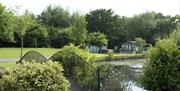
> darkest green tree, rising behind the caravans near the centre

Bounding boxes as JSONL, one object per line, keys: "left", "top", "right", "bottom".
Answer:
{"left": 86, "top": 9, "right": 125, "bottom": 48}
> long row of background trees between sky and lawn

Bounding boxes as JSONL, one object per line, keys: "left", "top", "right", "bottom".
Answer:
{"left": 0, "top": 4, "right": 180, "bottom": 49}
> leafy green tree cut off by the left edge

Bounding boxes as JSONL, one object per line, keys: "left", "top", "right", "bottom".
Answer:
{"left": 0, "top": 3, "right": 14, "bottom": 43}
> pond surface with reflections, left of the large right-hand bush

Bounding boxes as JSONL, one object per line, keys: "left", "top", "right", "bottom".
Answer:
{"left": 96, "top": 60, "right": 146, "bottom": 91}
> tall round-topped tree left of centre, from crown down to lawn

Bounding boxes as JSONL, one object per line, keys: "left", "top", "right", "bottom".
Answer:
{"left": 38, "top": 5, "right": 72, "bottom": 48}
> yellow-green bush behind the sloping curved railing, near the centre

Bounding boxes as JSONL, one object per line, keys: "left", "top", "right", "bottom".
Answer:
{"left": 52, "top": 45, "right": 95, "bottom": 88}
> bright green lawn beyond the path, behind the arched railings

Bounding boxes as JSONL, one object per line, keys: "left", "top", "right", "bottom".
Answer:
{"left": 0, "top": 48, "right": 60, "bottom": 59}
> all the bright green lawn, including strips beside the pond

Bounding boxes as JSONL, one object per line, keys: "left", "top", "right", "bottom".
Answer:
{"left": 0, "top": 48, "right": 143, "bottom": 67}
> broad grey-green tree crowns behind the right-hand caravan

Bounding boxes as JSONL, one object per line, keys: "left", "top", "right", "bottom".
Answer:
{"left": 125, "top": 12, "right": 177, "bottom": 45}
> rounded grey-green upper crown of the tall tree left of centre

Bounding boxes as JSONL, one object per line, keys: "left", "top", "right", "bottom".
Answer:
{"left": 39, "top": 5, "right": 71, "bottom": 28}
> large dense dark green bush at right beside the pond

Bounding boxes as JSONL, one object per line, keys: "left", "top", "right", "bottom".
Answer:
{"left": 139, "top": 39, "right": 180, "bottom": 91}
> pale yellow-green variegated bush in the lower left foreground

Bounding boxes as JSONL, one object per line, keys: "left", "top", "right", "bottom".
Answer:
{"left": 0, "top": 61, "right": 70, "bottom": 91}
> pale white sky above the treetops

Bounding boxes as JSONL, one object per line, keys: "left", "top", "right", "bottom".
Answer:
{"left": 0, "top": 0, "right": 180, "bottom": 16}
